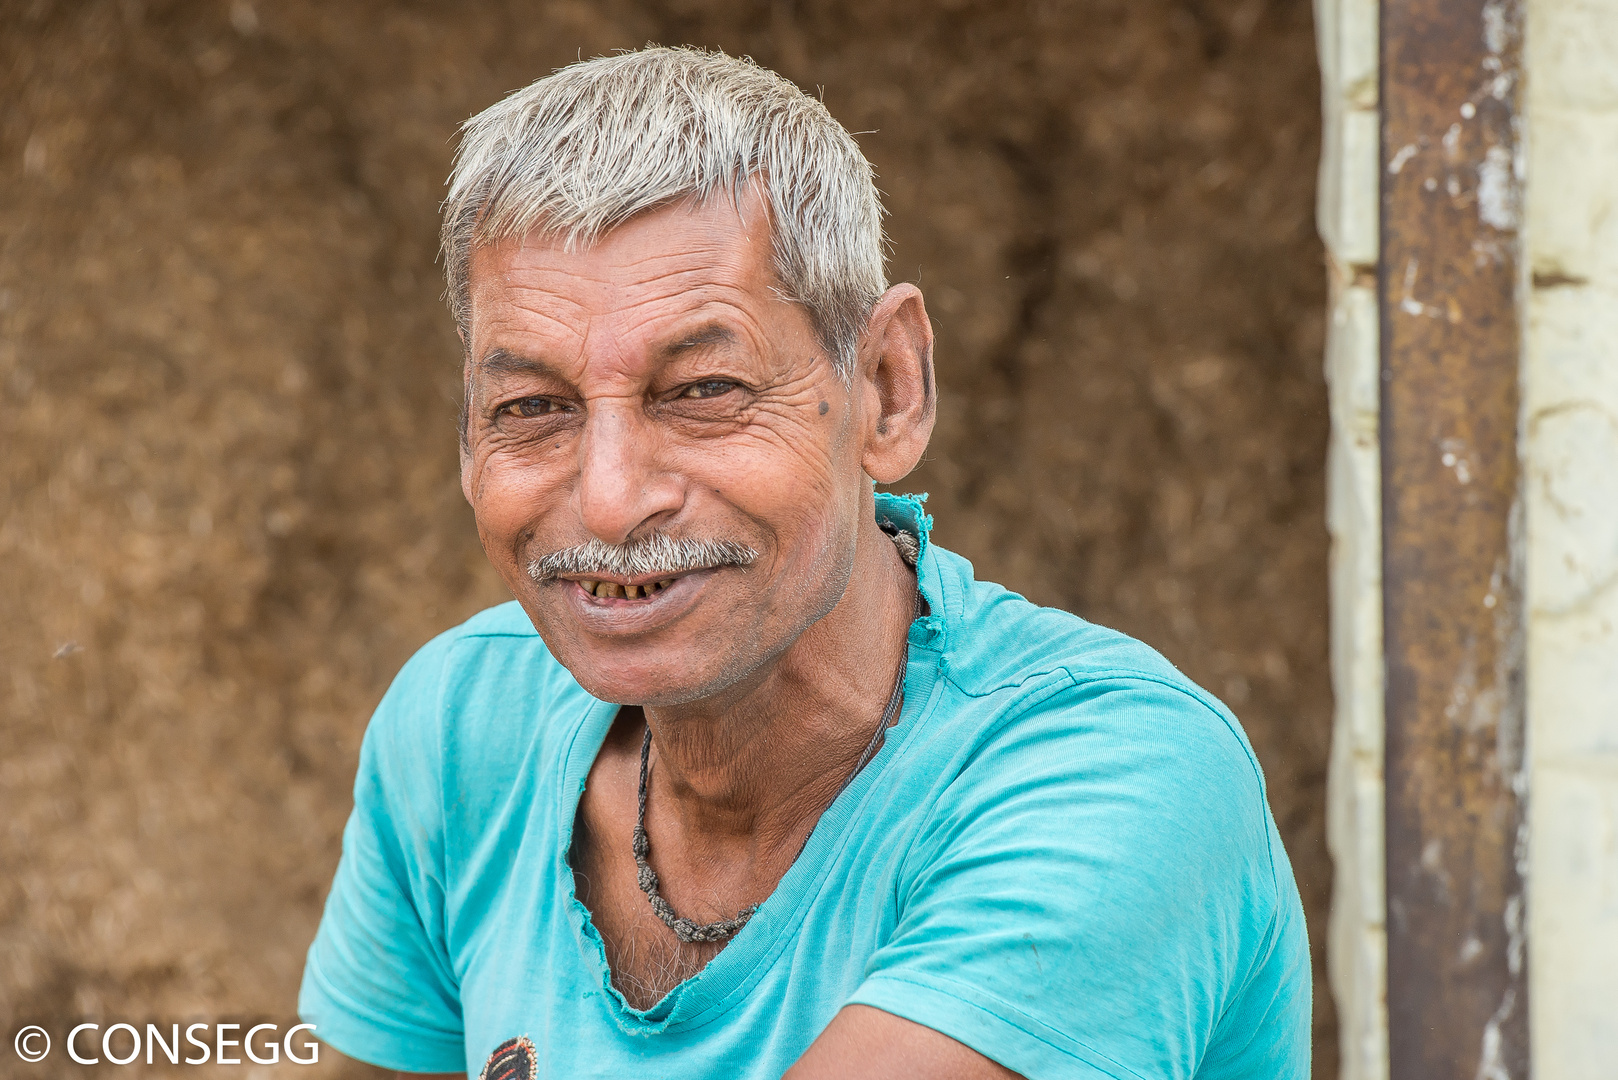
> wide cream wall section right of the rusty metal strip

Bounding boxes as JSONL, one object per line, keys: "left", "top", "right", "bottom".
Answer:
{"left": 1523, "top": 0, "right": 1618, "bottom": 1080}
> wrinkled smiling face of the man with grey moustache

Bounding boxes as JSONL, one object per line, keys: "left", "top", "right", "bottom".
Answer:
{"left": 461, "top": 193, "right": 869, "bottom": 704}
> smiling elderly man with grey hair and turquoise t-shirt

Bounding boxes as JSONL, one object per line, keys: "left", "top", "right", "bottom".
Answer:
{"left": 301, "top": 49, "right": 1309, "bottom": 1080}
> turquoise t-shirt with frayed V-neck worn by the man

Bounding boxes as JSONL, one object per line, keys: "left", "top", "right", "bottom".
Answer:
{"left": 299, "top": 495, "right": 1311, "bottom": 1080}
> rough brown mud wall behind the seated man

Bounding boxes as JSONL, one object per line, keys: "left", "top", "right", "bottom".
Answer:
{"left": 0, "top": 0, "right": 1335, "bottom": 1078}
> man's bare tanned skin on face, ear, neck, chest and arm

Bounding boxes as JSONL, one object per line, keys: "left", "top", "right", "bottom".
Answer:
{"left": 393, "top": 188, "right": 1013, "bottom": 1080}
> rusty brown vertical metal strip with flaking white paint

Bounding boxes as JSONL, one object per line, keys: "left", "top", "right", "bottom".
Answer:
{"left": 1379, "top": 0, "right": 1529, "bottom": 1080}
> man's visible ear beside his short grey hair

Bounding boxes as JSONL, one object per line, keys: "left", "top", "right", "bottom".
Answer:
{"left": 854, "top": 283, "right": 937, "bottom": 484}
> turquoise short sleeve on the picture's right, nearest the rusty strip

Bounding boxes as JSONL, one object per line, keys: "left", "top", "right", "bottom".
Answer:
{"left": 851, "top": 678, "right": 1307, "bottom": 1080}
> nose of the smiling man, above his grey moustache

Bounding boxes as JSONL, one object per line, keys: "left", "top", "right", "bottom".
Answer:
{"left": 576, "top": 397, "right": 684, "bottom": 544}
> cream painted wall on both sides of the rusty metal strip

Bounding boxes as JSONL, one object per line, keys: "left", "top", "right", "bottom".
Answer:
{"left": 1315, "top": 0, "right": 1618, "bottom": 1080}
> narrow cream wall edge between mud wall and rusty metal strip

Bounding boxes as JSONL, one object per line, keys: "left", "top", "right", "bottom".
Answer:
{"left": 1315, "top": 0, "right": 1388, "bottom": 1080}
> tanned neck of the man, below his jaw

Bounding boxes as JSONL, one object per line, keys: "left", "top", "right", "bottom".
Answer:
{"left": 646, "top": 518, "right": 916, "bottom": 861}
